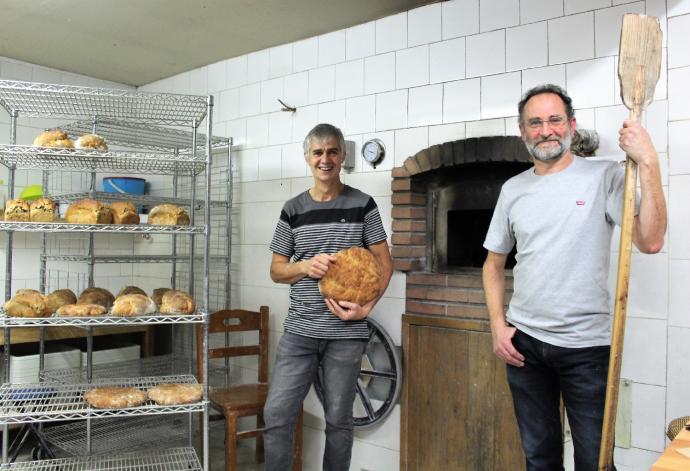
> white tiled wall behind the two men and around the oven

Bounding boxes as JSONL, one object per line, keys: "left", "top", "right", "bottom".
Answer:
{"left": 134, "top": 0, "right": 690, "bottom": 470}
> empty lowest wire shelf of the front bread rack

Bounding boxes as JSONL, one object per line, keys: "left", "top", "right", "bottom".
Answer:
{"left": 0, "top": 447, "right": 201, "bottom": 471}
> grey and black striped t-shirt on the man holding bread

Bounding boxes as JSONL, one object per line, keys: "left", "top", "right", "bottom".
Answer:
{"left": 270, "top": 185, "right": 386, "bottom": 339}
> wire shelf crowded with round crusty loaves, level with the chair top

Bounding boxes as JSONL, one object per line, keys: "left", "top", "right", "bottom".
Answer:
{"left": 0, "top": 286, "right": 205, "bottom": 327}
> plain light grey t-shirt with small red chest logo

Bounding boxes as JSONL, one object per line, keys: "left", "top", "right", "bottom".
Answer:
{"left": 484, "top": 157, "right": 625, "bottom": 348}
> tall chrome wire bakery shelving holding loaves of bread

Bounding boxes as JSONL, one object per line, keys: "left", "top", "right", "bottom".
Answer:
{"left": 0, "top": 80, "right": 220, "bottom": 471}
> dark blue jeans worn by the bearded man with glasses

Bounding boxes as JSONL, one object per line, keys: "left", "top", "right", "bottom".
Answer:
{"left": 507, "top": 330, "right": 610, "bottom": 471}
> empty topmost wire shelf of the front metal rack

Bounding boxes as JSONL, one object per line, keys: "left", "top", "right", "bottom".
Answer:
{"left": 0, "top": 80, "right": 208, "bottom": 126}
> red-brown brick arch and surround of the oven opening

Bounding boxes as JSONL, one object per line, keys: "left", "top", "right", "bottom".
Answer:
{"left": 391, "top": 136, "right": 530, "bottom": 320}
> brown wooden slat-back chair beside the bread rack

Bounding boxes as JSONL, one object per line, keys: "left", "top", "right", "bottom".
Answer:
{"left": 196, "top": 306, "right": 302, "bottom": 471}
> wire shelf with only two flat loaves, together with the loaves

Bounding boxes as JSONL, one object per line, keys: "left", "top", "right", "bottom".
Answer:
{"left": 0, "top": 375, "right": 203, "bottom": 424}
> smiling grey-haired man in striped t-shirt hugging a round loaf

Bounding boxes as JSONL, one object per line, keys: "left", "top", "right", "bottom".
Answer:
{"left": 264, "top": 124, "right": 393, "bottom": 471}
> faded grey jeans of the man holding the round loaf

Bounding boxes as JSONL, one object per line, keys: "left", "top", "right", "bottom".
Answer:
{"left": 264, "top": 332, "right": 367, "bottom": 471}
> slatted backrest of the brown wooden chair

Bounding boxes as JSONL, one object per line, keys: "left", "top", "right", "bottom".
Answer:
{"left": 196, "top": 306, "right": 268, "bottom": 383}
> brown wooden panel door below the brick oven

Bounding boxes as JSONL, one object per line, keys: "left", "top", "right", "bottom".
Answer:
{"left": 402, "top": 325, "right": 525, "bottom": 471}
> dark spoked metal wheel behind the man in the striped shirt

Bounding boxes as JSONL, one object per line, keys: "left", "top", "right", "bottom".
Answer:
{"left": 314, "top": 318, "right": 402, "bottom": 428}
